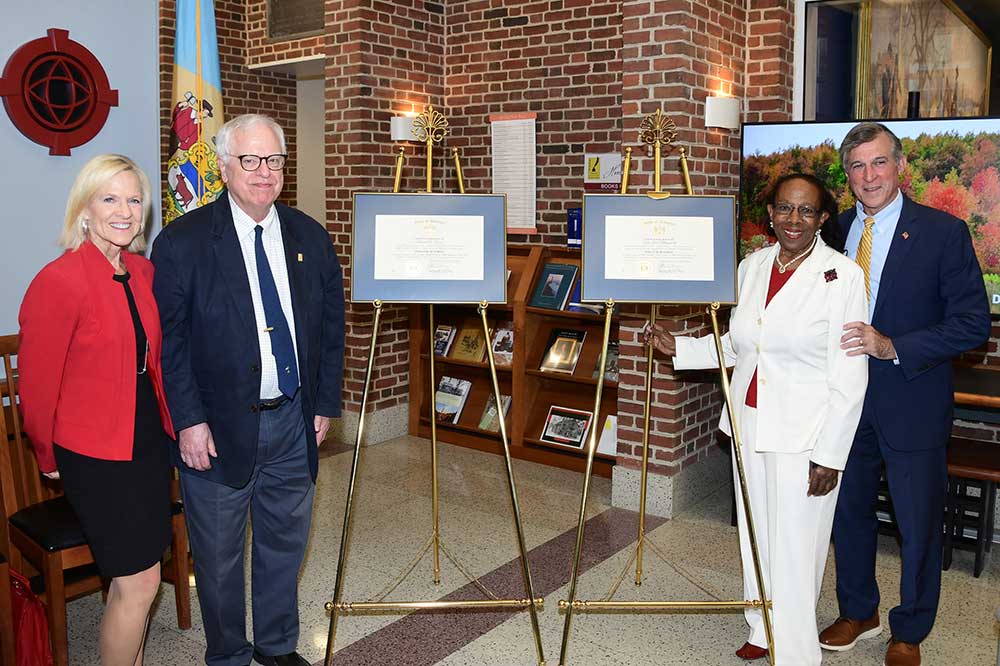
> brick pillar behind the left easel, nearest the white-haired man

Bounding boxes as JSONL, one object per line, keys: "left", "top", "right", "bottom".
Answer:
{"left": 325, "top": 0, "right": 448, "bottom": 442}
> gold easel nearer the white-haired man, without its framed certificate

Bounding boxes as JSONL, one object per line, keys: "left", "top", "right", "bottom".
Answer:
{"left": 324, "top": 106, "right": 545, "bottom": 666}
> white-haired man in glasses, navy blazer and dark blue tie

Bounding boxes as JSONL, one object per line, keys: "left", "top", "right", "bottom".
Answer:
{"left": 152, "top": 115, "right": 344, "bottom": 666}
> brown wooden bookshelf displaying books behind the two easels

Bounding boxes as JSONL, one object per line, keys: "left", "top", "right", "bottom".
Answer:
{"left": 409, "top": 245, "right": 618, "bottom": 476}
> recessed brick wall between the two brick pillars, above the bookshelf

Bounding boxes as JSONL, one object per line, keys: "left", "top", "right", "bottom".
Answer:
{"left": 445, "top": 0, "right": 622, "bottom": 245}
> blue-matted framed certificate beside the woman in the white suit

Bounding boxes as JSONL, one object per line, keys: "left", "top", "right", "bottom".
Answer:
{"left": 582, "top": 194, "right": 737, "bottom": 305}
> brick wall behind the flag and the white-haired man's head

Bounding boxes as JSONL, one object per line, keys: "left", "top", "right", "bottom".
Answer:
{"left": 159, "top": 0, "right": 296, "bottom": 205}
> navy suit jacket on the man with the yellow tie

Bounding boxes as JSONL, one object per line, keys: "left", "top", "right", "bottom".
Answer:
{"left": 839, "top": 196, "right": 990, "bottom": 451}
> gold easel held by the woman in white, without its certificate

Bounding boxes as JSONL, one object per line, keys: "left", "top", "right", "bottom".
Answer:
{"left": 559, "top": 109, "right": 774, "bottom": 666}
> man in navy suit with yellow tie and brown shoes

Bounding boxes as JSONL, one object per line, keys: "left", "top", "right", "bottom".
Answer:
{"left": 820, "top": 122, "right": 990, "bottom": 666}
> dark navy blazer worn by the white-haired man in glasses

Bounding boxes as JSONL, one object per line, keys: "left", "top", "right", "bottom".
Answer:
{"left": 151, "top": 194, "right": 344, "bottom": 487}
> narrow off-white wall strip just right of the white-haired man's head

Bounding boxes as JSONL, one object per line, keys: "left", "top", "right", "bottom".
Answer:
{"left": 295, "top": 77, "right": 326, "bottom": 224}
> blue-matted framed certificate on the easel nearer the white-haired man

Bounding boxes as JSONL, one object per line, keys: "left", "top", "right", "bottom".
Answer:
{"left": 351, "top": 192, "right": 507, "bottom": 303}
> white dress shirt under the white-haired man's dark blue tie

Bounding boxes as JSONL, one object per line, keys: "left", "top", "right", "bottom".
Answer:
{"left": 229, "top": 192, "right": 301, "bottom": 400}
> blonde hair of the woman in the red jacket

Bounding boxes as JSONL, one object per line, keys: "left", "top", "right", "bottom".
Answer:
{"left": 59, "top": 153, "right": 153, "bottom": 252}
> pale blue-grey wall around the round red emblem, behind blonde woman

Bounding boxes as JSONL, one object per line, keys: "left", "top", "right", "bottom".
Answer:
{"left": 0, "top": 0, "right": 161, "bottom": 335}
